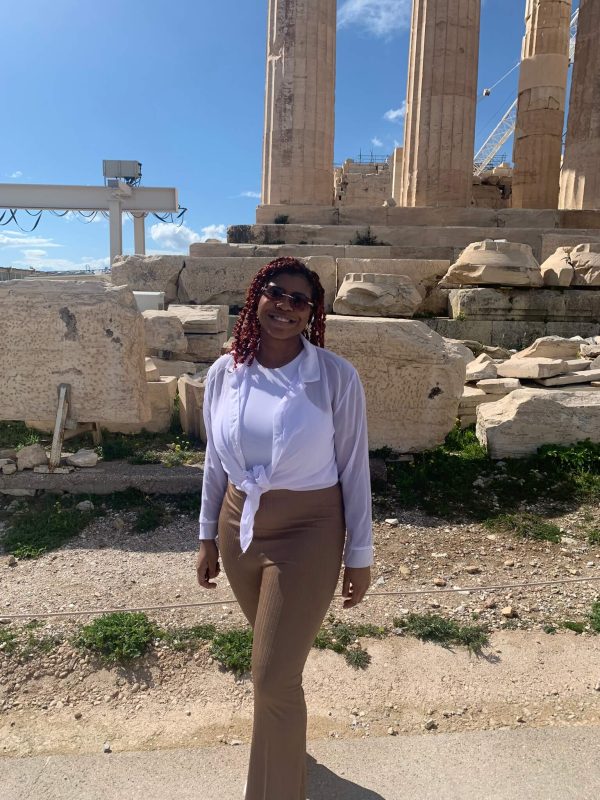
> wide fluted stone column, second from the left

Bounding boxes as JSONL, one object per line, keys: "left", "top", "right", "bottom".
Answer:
{"left": 400, "top": 0, "right": 481, "bottom": 206}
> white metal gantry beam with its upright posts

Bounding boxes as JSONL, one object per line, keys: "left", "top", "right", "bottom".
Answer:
{"left": 0, "top": 181, "right": 179, "bottom": 264}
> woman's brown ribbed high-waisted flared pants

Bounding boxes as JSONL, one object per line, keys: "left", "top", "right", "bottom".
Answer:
{"left": 219, "top": 484, "right": 345, "bottom": 800}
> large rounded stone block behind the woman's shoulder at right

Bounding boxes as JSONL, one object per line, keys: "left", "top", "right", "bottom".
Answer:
{"left": 326, "top": 316, "right": 465, "bottom": 453}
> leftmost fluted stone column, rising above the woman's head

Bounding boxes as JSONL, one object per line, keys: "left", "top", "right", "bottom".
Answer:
{"left": 262, "top": 0, "right": 337, "bottom": 205}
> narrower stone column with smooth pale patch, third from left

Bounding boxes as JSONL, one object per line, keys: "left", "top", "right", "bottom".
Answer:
{"left": 512, "top": 0, "right": 571, "bottom": 208}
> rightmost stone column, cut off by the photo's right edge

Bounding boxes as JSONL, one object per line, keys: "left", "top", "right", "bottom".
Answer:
{"left": 559, "top": 0, "right": 600, "bottom": 209}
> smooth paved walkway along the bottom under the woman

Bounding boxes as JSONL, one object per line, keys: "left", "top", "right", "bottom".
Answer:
{"left": 0, "top": 727, "right": 600, "bottom": 800}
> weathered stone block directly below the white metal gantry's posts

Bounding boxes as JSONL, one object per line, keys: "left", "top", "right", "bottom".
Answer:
{"left": 111, "top": 255, "right": 185, "bottom": 303}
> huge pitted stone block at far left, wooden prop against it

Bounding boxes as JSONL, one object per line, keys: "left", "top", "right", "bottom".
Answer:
{"left": 0, "top": 280, "right": 150, "bottom": 424}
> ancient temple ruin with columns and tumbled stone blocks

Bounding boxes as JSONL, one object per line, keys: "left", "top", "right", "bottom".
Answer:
{"left": 0, "top": 0, "right": 600, "bottom": 480}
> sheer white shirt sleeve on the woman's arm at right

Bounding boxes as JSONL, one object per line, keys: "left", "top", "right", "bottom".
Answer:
{"left": 333, "top": 372, "right": 373, "bottom": 567}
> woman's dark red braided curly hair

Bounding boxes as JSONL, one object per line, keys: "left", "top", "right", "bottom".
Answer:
{"left": 230, "top": 256, "right": 325, "bottom": 367}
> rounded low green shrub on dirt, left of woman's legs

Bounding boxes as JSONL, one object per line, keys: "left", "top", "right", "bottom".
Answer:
{"left": 74, "top": 611, "right": 159, "bottom": 662}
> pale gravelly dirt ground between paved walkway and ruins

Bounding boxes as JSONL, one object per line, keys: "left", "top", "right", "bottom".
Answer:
{"left": 0, "top": 500, "right": 600, "bottom": 756}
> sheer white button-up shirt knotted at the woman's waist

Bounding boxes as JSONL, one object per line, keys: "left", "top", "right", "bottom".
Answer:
{"left": 199, "top": 337, "right": 373, "bottom": 567}
